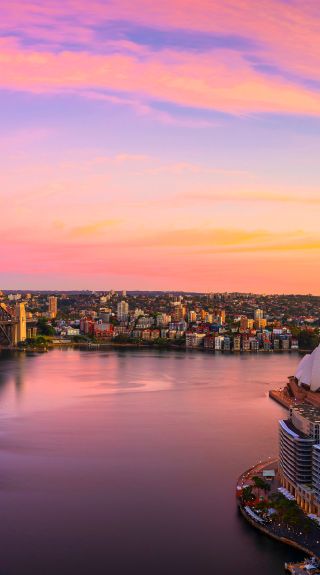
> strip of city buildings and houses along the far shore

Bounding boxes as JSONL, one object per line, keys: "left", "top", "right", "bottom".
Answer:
{"left": 0, "top": 290, "right": 320, "bottom": 352}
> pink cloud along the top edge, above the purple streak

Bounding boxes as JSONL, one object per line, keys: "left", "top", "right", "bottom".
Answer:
{"left": 1, "top": 0, "right": 320, "bottom": 83}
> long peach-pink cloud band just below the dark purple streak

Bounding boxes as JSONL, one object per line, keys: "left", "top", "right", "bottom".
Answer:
{"left": 0, "top": 40, "right": 320, "bottom": 115}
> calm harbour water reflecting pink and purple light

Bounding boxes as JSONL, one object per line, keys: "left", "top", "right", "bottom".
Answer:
{"left": 0, "top": 350, "right": 300, "bottom": 575}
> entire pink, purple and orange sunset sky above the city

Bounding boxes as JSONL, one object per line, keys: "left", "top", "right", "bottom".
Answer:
{"left": 0, "top": 0, "right": 320, "bottom": 295}
